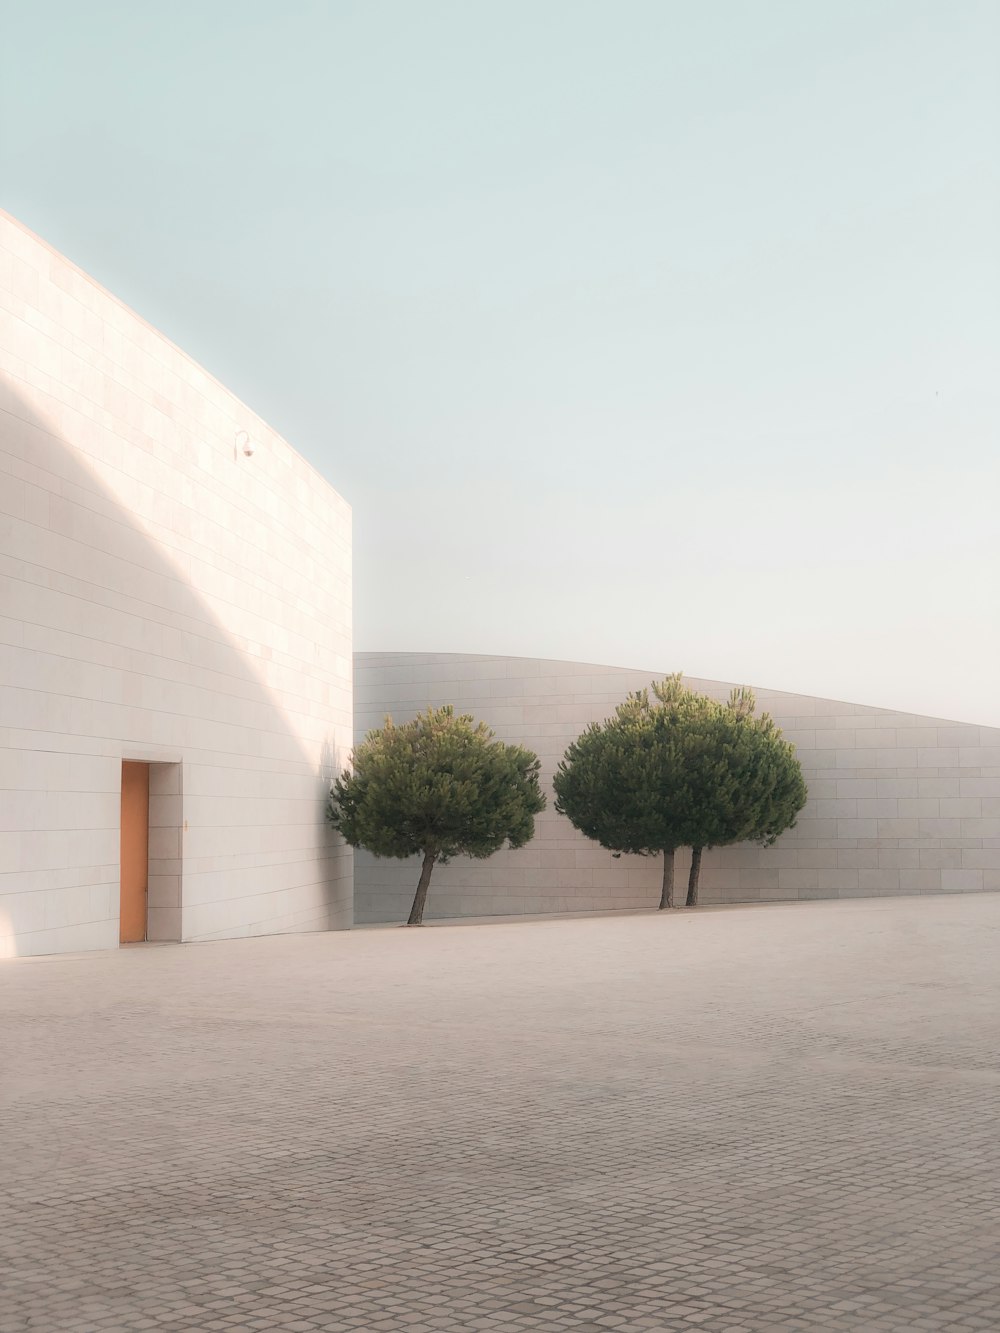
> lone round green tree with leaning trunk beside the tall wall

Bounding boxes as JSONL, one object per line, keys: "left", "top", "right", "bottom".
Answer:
{"left": 328, "top": 706, "right": 545, "bottom": 925}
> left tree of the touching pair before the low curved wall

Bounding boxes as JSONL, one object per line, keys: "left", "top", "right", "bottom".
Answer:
{"left": 553, "top": 674, "right": 719, "bottom": 909}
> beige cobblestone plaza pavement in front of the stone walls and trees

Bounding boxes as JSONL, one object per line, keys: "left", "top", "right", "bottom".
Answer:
{"left": 0, "top": 894, "right": 1000, "bottom": 1333}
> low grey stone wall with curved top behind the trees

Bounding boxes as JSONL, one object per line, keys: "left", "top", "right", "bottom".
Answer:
{"left": 355, "top": 653, "right": 1000, "bottom": 922}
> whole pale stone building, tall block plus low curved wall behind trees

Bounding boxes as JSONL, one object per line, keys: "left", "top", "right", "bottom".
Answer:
{"left": 0, "top": 213, "right": 1000, "bottom": 957}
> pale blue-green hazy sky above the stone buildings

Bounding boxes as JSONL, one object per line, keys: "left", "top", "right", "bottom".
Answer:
{"left": 0, "top": 0, "right": 1000, "bottom": 725}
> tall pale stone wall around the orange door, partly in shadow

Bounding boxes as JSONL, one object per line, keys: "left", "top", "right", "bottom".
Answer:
{"left": 0, "top": 215, "right": 352, "bottom": 953}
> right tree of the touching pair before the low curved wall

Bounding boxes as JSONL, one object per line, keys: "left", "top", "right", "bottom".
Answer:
{"left": 687, "top": 688, "right": 807, "bottom": 908}
